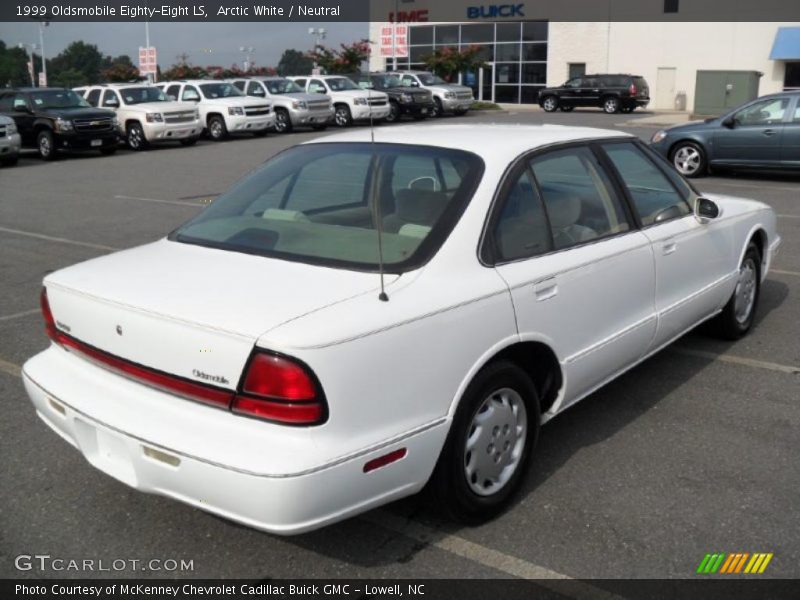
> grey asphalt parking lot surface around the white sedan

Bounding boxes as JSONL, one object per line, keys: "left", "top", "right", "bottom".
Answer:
{"left": 0, "top": 110, "right": 800, "bottom": 579}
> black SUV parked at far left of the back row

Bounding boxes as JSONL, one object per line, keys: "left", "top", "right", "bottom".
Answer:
{"left": 0, "top": 88, "right": 119, "bottom": 160}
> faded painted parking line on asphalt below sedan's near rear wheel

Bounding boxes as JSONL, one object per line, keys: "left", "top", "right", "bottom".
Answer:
{"left": 360, "top": 510, "right": 619, "bottom": 600}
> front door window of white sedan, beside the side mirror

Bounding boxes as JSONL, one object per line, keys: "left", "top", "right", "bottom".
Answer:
{"left": 603, "top": 143, "right": 692, "bottom": 226}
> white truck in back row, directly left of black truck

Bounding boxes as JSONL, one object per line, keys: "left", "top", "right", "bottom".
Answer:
{"left": 289, "top": 75, "right": 391, "bottom": 127}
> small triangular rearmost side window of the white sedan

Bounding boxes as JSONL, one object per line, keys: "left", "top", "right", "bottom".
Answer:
{"left": 494, "top": 169, "right": 552, "bottom": 260}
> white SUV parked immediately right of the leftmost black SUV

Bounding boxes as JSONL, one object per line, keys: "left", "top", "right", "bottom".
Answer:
{"left": 74, "top": 83, "right": 203, "bottom": 150}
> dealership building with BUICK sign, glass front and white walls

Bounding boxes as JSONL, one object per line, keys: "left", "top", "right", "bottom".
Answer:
{"left": 369, "top": 0, "right": 800, "bottom": 111}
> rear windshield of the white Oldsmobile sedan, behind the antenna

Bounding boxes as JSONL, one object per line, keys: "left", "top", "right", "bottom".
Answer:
{"left": 170, "top": 143, "right": 483, "bottom": 273}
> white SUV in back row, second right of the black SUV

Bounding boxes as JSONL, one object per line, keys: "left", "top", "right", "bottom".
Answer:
{"left": 158, "top": 79, "right": 275, "bottom": 141}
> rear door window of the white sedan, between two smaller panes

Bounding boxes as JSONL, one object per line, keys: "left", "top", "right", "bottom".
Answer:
{"left": 531, "top": 147, "right": 630, "bottom": 250}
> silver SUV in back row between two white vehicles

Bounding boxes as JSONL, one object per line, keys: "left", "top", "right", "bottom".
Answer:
{"left": 228, "top": 77, "right": 333, "bottom": 133}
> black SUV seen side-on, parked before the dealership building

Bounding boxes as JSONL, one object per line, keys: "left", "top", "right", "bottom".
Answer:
{"left": 539, "top": 75, "right": 650, "bottom": 114}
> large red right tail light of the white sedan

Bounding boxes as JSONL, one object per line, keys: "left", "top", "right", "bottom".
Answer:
{"left": 231, "top": 352, "right": 327, "bottom": 425}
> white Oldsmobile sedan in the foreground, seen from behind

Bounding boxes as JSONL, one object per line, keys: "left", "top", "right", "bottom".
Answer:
{"left": 23, "top": 125, "right": 780, "bottom": 534}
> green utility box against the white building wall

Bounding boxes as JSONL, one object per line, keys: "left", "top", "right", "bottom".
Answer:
{"left": 694, "top": 71, "right": 763, "bottom": 117}
